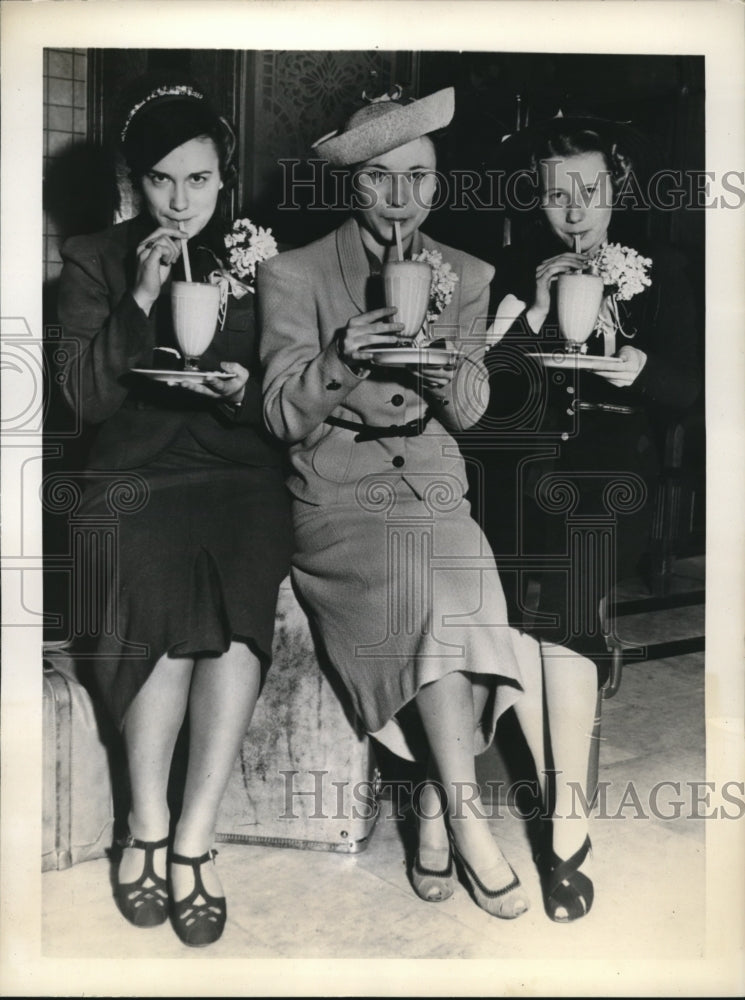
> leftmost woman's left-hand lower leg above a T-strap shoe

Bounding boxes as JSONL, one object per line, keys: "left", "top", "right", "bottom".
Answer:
{"left": 119, "top": 655, "right": 194, "bottom": 882}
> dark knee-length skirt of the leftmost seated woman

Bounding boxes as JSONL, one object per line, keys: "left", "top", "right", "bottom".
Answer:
{"left": 76, "top": 432, "right": 292, "bottom": 726}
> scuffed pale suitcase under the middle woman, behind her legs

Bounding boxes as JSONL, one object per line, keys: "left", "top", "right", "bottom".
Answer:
{"left": 216, "top": 578, "right": 380, "bottom": 854}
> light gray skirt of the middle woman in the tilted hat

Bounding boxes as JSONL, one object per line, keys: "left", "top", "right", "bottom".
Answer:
{"left": 292, "top": 480, "right": 522, "bottom": 760}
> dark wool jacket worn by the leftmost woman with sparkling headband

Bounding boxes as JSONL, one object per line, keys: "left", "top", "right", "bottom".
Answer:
{"left": 59, "top": 215, "right": 282, "bottom": 469}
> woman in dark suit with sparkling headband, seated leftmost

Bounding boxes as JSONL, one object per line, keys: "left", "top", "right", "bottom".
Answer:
{"left": 59, "top": 82, "right": 291, "bottom": 945}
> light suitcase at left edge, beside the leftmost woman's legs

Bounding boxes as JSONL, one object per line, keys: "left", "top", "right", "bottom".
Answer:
{"left": 41, "top": 651, "right": 114, "bottom": 871}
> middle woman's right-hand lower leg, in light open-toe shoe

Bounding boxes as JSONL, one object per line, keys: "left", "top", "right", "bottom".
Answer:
{"left": 416, "top": 673, "right": 527, "bottom": 912}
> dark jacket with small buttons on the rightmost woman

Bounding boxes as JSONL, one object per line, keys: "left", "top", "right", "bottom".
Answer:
{"left": 476, "top": 240, "right": 702, "bottom": 456}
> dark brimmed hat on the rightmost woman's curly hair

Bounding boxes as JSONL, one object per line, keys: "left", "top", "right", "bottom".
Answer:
{"left": 500, "top": 114, "right": 651, "bottom": 169}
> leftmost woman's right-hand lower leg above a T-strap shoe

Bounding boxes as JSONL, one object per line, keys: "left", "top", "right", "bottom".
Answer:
{"left": 171, "top": 642, "right": 261, "bottom": 900}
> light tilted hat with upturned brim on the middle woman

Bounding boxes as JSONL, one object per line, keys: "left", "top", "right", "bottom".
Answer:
{"left": 312, "top": 87, "right": 455, "bottom": 167}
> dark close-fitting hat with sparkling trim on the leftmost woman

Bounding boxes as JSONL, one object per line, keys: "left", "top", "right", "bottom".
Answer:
{"left": 120, "top": 84, "right": 221, "bottom": 175}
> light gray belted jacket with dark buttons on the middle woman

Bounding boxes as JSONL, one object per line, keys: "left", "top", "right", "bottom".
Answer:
{"left": 258, "top": 218, "right": 494, "bottom": 504}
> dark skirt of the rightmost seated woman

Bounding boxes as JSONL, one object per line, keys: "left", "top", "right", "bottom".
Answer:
{"left": 471, "top": 413, "right": 658, "bottom": 685}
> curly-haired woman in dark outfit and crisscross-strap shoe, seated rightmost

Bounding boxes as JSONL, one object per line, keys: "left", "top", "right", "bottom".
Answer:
{"left": 476, "top": 118, "right": 700, "bottom": 922}
